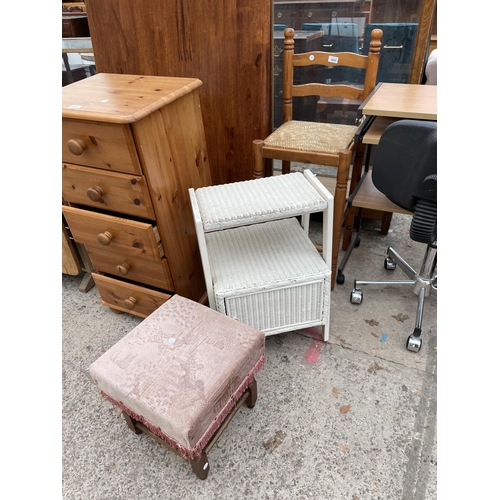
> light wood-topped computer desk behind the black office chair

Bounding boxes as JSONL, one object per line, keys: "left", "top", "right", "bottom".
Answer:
{"left": 342, "top": 83, "right": 437, "bottom": 250}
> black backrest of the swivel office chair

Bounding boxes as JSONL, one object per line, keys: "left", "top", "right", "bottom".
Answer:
{"left": 372, "top": 120, "right": 437, "bottom": 212}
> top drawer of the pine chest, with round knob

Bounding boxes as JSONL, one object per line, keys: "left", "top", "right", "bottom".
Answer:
{"left": 62, "top": 118, "right": 142, "bottom": 175}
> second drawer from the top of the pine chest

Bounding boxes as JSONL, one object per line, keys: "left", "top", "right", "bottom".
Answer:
{"left": 62, "top": 163, "right": 155, "bottom": 219}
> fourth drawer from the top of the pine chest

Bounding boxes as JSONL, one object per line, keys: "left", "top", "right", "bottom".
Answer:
{"left": 85, "top": 246, "right": 174, "bottom": 290}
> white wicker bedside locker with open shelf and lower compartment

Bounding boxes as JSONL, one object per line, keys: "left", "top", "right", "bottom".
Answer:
{"left": 189, "top": 170, "right": 333, "bottom": 342}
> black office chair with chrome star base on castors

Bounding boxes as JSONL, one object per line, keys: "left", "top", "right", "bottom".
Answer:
{"left": 351, "top": 120, "right": 437, "bottom": 352}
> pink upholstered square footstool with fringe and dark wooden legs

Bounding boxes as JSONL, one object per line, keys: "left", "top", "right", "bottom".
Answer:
{"left": 90, "top": 295, "right": 265, "bottom": 479}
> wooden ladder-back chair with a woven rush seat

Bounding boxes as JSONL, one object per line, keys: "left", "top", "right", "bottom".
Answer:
{"left": 253, "top": 28, "right": 383, "bottom": 288}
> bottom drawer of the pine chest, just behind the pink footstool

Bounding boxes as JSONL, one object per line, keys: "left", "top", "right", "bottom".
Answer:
{"left": 92, "top": 273, "right": 172, "bottom": 318}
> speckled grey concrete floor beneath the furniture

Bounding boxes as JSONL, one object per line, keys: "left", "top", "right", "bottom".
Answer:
{"left": 62, "top": 208, "right": 437, "bottom": 500}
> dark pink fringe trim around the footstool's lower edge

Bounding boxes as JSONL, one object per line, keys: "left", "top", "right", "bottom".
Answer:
{"left": 101, "top": 354, "right": 266, "bottom": 460}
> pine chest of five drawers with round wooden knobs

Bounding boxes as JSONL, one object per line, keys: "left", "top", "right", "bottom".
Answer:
{"left": 62, "top": 73, "right": 211, "bottom": 317}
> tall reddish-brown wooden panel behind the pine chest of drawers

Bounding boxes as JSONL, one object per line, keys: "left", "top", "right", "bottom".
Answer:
{"left": 86, "top": 0, "right": 272, "bottom": 184}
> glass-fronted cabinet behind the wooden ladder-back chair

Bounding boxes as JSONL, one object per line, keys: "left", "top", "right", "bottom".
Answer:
{"left": 273, "top": 0, "right": 437, "bottom": 128}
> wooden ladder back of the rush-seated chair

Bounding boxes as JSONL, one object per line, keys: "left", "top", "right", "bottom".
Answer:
{"left": 283, "top": 28, "right": 383, "bottom": 122}
